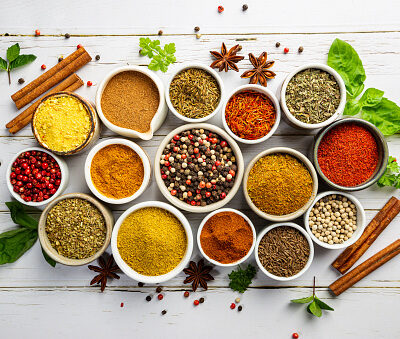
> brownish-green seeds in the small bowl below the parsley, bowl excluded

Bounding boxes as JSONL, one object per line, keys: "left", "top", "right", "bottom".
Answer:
{"left": 169, "top": 68, "right": 221, "bottom": 119}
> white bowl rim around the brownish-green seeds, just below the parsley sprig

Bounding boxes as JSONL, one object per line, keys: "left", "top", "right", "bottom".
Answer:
{"left": 165, "top": 63, "right": 224, "bottom": 122}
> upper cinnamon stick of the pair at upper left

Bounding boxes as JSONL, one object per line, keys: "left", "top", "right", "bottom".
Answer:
{"left": 11, "top": 47, "right": 92, "bottom": 109}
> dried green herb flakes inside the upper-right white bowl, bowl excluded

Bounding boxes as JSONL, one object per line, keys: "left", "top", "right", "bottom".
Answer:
{"left": 285, "top": 68, "right": 340, "bottom": 124}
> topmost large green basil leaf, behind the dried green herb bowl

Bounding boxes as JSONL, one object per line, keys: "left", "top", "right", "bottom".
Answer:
{"left": 328, "top": 39, "right": 366, "bottom": 98}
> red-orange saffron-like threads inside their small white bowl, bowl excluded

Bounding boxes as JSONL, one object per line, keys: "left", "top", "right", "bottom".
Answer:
{"left": 225, "top": 91, "right": 276, "bottom": 140}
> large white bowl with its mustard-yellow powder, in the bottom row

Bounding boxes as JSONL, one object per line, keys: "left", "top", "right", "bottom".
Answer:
{"left": 111, "top": 201, "right": 193, "bottom": 284}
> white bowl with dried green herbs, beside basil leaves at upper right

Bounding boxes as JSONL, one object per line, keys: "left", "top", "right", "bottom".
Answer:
{"left": 281, "top": 64, "right": 346, "bottom": 129}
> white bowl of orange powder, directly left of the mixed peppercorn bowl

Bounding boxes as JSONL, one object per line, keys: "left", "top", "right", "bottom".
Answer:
{"left": 85, "top": 138, "right": 151, "bottom": 204}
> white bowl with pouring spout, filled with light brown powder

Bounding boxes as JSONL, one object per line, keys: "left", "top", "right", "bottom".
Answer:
{"left": 96, "top": 66, "right": 168, "bottom": 140}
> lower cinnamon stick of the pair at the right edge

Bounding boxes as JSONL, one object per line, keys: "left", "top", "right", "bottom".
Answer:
{"left": 329, "top": 239, "right": 400, "bottom": 296}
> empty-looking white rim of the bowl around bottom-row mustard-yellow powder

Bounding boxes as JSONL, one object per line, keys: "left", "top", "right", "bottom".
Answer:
{"left": 111, "top": 201, "right": 193, "bottom": 284}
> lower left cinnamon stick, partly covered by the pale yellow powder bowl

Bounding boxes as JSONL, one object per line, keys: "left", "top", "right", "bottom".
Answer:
{"left": 6, "top": 73, "right": 83, "bottom": 134}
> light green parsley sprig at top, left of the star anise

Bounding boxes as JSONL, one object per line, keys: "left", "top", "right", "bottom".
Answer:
{"left": 139, "top": 38, "right": 176, "bottom": 73}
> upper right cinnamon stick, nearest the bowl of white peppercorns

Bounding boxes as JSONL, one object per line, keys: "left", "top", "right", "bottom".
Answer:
{"left": 332, "top": 197, "right": 400, "bottom": 274}
